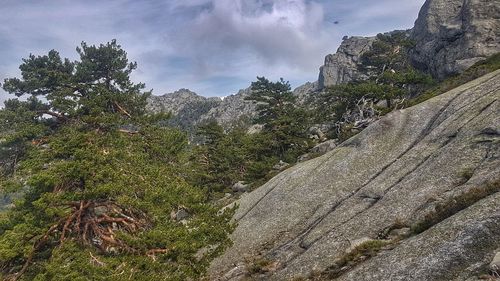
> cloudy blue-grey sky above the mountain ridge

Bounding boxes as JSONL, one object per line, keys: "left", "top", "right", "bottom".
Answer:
{"left": 0, "top": 0, "right": 424, "bottom": 103}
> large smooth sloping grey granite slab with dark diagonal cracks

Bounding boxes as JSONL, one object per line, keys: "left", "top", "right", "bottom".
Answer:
{"left": 210, "top": 70, "right": 500, "bottom": 281}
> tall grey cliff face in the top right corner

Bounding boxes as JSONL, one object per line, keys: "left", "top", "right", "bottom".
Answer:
{"left": 411, "top": 0, "right": 500, "bottom": 79}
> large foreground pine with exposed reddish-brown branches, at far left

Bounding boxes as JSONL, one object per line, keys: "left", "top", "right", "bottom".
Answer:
{"left": 0, "top": 41, "right": 232, "bottom": 280}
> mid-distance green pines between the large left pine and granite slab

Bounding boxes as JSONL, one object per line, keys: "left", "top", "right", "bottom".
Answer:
{"left": 192, "top": 77, "right": 312, "bottom": 197}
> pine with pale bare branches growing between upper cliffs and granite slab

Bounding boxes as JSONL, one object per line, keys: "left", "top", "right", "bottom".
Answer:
{"left": 312, "top": 31, "right": 434, "bottom": 140}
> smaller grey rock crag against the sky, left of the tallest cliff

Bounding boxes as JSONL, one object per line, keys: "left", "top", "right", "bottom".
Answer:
{"left": 318, "top": 36, "right": 375, "bottom": 89}
